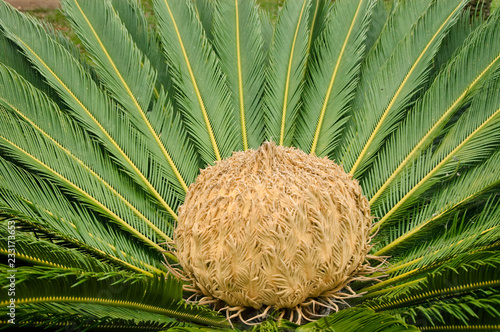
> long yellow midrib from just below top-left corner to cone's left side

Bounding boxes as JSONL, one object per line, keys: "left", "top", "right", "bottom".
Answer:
{"left": 12, "top": 37, "right": 178, "bottom": 221}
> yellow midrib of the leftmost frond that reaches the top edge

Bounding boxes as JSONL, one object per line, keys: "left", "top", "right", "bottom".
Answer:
{"left": 74, "top": 0, "right": 188, "bottom": 193}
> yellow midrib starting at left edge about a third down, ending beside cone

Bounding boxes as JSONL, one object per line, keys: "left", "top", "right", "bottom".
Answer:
{"left": 0, "top": 98, "right": 172, "bottom": 241}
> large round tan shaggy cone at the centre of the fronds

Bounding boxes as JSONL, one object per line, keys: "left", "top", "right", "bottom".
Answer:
{"left": 175, "top": 143, "right": 371, "bottom": 309}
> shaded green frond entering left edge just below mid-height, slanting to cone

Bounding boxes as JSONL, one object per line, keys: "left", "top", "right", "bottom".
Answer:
{"left": 0, "top": 158, "right": 163, "bottom": 274}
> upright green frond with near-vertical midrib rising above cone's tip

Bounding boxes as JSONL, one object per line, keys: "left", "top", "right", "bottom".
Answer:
{"left": 214, "top": 0, "right": 265, "bottom": 150}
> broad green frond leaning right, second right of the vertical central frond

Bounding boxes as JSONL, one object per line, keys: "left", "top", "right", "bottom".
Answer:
{"left": 295, "top": 0, "right": 374, "bottom": 157}
